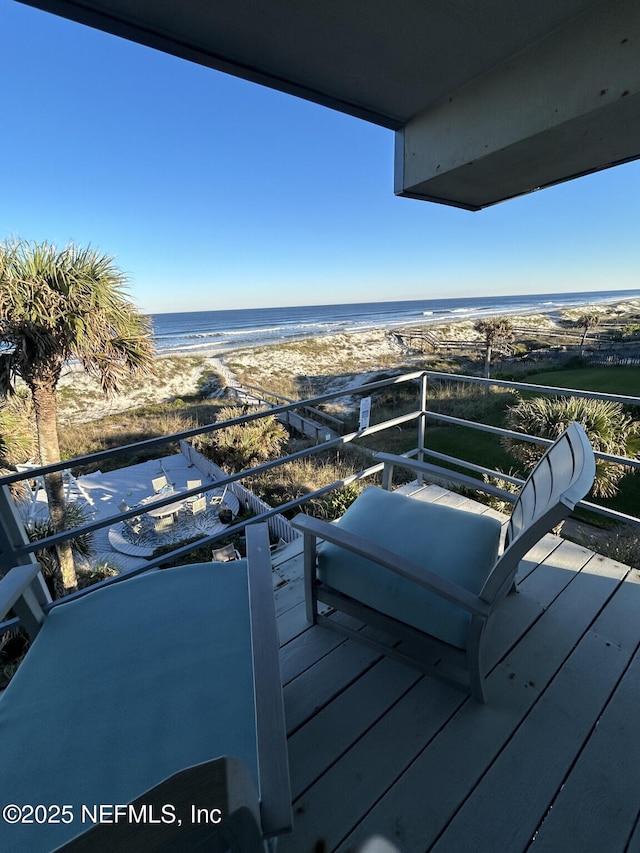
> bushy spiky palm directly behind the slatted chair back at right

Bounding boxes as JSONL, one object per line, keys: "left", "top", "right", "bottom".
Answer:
{"left": 504, "top": 397, "right": 640, "bottom": 498}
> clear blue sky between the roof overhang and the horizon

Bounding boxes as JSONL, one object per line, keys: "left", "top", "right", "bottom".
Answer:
{"left": 0, "top": 0, "right": 640, "bottom": 312}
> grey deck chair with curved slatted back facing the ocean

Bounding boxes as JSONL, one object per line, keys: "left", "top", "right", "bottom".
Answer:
{"left": 292, "top": 423, "right": 595, "bottom": 702}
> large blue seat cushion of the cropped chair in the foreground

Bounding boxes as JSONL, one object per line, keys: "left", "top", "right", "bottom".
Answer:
{"left": 0, "top": 560, "right": 258, "bottom": 853}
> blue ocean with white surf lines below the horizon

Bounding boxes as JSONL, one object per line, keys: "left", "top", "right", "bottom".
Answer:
{"left": 151, "top": 290, "right": 640, "bottom": 355}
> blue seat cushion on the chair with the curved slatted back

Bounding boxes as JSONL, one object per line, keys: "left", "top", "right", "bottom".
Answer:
{"left": 318, "top": 486, "right": 501, "bottom": 649}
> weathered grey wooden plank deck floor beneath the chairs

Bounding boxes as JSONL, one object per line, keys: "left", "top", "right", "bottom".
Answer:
{"left": 274, "top": 486, "right": 640, "bottom": 853}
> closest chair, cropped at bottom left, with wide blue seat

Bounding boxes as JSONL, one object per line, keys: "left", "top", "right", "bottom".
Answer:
{"left": 0, "top": 524, "right": 291, "bottom": 853}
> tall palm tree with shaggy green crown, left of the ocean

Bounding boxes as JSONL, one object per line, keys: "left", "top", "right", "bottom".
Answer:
{"left": 0, "top": 236, "right": 153, "bottom": 590}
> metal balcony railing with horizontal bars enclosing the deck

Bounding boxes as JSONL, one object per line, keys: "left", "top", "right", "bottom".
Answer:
{"left": 0, "top": 371, "right": 640, "bottom": 632}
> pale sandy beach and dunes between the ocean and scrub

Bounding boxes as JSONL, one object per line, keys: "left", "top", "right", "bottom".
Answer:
{"left": 58, "top": 300, "right": 640, "bottom": 424}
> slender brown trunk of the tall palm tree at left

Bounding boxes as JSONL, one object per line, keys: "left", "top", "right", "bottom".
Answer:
{"left": 31, "top": 382, "right": 78, "bottom": 592}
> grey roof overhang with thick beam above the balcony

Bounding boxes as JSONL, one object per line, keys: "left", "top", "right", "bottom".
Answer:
{"left": 16, "top": 0, "right": 640, "bottom": 210}
